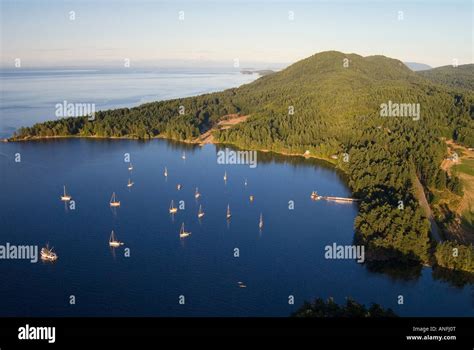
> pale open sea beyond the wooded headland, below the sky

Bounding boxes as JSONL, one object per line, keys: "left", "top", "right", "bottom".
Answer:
{"left": 0, "top": 68, "right": 258, "bottom": 138}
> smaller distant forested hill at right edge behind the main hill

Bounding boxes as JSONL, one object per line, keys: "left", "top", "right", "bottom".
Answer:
{"left": 417, "top": 64, "right": 474, "bottom": 91}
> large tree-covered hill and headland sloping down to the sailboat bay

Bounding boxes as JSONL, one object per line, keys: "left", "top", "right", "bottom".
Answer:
{"left": 12, "top": 51, "right": 474, "bottom": 272}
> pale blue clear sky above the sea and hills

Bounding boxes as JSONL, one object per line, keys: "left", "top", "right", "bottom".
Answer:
{"left": 0, "top": 0, "right": 474, "bottom": 68}
